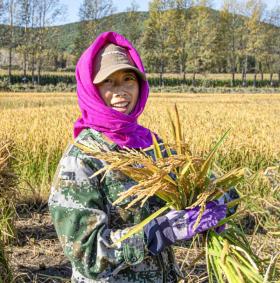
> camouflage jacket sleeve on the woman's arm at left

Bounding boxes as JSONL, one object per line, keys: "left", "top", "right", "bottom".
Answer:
{"left": 49, "top": 153, "right": 145, "bottom": 279}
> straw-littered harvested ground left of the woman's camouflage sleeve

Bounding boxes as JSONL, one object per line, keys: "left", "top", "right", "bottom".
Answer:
{"left": 9, "top": 206, "right": 71, "bottom": 283}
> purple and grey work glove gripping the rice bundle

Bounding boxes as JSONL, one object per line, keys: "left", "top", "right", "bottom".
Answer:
{"left": 144, "top": 201, "right": 226, "bottom": 255}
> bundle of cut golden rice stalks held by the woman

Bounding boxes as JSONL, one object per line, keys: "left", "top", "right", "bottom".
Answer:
{"left": 76, "top": 106, "right": 278, "bottom": 283}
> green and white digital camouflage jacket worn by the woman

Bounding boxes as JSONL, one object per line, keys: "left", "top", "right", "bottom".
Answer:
{"left": 49, "top": 129, "right": 183, "bottom": 283}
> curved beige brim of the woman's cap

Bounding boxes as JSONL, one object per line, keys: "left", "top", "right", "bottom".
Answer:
{"left": 93, "top": 64, "right": 146, "bottom": 84}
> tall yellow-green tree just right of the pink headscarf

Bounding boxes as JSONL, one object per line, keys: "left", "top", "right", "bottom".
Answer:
{"left": 142, "top": 0, "right": 171, "bottom": 86}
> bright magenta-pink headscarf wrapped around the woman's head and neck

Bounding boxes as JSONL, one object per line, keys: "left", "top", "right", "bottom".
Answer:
{"left": 74, "top": 32, "right": 152, "bottom": 148}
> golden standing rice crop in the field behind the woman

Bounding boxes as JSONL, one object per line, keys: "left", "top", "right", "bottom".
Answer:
{"left": 0, "top": 93, "right": 280, "bottom": 196}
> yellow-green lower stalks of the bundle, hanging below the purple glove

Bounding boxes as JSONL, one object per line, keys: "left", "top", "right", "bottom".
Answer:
{"left": 206, "top": 225, "right": 264, "bottom": 283}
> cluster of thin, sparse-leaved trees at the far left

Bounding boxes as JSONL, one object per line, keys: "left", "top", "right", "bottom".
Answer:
{"left": 0, "top": 0, "right": 64, "bottom": 83}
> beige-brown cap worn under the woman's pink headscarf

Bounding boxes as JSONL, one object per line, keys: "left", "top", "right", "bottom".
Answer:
{"left": 93, "top": 43, "right": 146, "bottom": 84}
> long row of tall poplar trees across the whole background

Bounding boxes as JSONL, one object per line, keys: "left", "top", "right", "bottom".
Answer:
{"left": 0, "top": 0, "right": 280, "bottom": 85}
